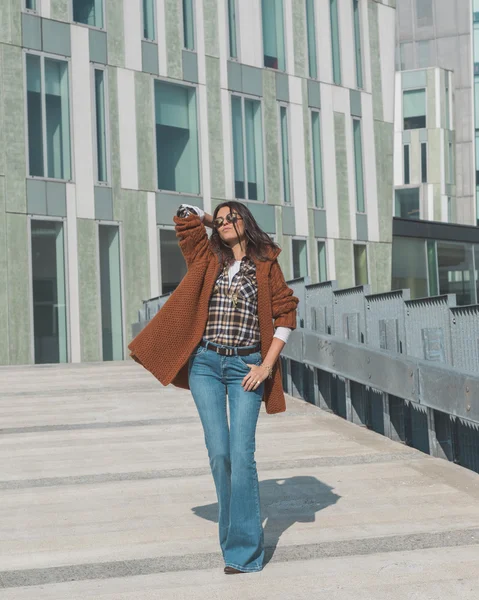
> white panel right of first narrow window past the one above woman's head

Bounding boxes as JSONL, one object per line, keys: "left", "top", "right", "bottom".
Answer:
{"left": 289, "top": 104, "right": 309, "bottom": 237}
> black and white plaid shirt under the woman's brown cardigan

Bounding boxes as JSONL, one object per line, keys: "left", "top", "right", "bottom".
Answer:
{"left": 203, "top": 256, "right": 260, "bottom": 346}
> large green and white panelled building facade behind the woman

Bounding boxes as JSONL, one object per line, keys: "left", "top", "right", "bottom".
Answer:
{"left": 0, "top": 0, "right": 395, "bottom": 364}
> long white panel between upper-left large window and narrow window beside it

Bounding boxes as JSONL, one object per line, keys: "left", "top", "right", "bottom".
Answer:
{"left": 71, "top": 25, "right": 95, "bottom": 219}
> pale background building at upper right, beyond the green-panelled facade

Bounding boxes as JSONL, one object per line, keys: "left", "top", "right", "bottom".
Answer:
{"left": 395, "top": 0, "right": 479, "bottom": 225}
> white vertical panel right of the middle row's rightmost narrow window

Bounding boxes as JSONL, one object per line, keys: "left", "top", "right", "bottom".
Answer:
{"left": 361, "top": 93, "right": 380, "bottom": 242}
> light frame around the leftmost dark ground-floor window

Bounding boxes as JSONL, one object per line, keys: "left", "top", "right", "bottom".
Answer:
{"left": 27, "top": 214, "right": 72, "bottom": 365}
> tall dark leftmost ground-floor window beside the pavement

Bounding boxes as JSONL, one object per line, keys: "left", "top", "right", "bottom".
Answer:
{"left": 31, "top": 220, "right": 68, "bottom": 364}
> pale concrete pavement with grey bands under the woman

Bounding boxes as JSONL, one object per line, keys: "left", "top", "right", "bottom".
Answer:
{"left": 0, "top": 362, "right": 479, "bottom": 600}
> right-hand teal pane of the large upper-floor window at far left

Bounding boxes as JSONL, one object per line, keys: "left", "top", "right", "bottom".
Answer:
{"left": 45, "top": 58, "right": 71, "bottom": 179}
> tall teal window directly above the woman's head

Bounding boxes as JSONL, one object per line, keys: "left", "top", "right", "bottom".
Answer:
{"left": 231, "top": 96, "right": 264, "bottom": 200}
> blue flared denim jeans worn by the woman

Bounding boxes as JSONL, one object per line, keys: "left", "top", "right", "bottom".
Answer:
{"left": 188, "top": 344, "right": 264, "bottom": 571}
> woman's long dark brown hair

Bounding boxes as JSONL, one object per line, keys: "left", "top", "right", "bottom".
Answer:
{"left": 210, "top": 200, "right": 279, "bottom": 265}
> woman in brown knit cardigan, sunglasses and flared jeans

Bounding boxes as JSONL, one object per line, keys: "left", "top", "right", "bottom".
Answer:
{"left": 129, "top": 202, "right": 298, "bottom": 574}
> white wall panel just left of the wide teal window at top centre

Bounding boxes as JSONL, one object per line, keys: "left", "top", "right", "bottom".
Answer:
{"left": 237, "top": 0, "right": 263, "bottom": 67}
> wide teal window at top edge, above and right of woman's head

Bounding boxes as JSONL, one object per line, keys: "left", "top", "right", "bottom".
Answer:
{"left": 261, "top": 0, "right": 286, "bottom": 71}
